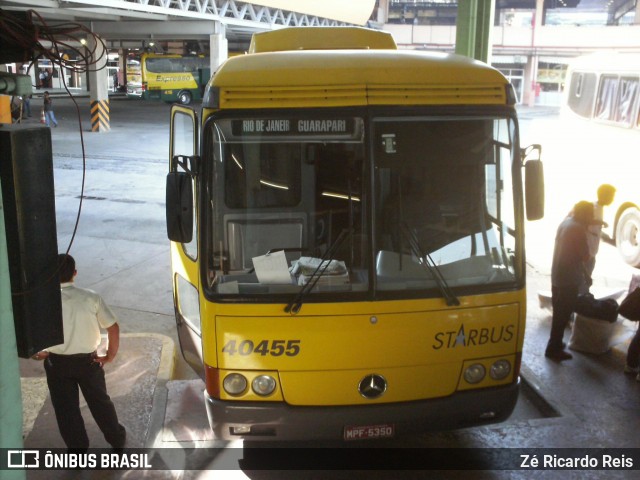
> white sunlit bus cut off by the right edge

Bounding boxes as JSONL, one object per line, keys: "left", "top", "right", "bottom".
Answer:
{"left": 563, "top": 52, "right": 640, "bottom": 267}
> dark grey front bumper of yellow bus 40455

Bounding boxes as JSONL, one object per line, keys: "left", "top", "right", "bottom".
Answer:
{"left": 204, "top": 381, "right": 520, "bottom": 440}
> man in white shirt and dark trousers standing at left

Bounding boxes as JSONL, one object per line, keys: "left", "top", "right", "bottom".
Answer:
{"left": 34, "top": 254, "right": 126, "bottom": 451}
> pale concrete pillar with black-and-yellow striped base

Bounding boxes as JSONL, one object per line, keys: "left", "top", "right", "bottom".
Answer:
{"left": 87, "top": 35, "right": 111, "bottom": 132}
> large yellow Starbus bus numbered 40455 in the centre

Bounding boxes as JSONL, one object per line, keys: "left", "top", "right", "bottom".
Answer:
{"left": 167, "top": 27, "right": 543, "bottom": 440}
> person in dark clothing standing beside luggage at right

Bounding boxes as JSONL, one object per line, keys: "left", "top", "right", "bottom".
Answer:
{"left": 545, "top": 201, "right": 593, "bottom": 361}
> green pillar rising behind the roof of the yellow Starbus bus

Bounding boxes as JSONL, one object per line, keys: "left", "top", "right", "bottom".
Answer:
{"left": 456, "top": 0, "right": 495, "bottom": 63}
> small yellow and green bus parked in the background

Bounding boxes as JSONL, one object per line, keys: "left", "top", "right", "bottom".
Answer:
{"left": 127, "top": 53, "right": 211, "bottom": 105}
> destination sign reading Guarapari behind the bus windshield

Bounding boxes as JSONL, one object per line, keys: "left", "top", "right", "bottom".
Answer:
{"left": 232, "top": 118, "right": 355, "bottom": 136}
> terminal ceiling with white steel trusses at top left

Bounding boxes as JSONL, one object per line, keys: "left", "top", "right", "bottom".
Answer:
{"left": 0, "top": 0, "right": 375, "bottom": 50}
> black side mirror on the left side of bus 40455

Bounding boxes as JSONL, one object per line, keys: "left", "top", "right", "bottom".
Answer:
{"left": 166, "top": 172, "right": 193, "bottom": 243}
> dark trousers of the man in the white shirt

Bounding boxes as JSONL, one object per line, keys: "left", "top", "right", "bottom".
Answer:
{"left": 44, "top": 354, "right": 126, "bottom": 450}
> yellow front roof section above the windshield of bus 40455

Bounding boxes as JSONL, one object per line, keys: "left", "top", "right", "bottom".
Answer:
{"left": 211, "top": 45, "right": 510, "bottom": 108}
